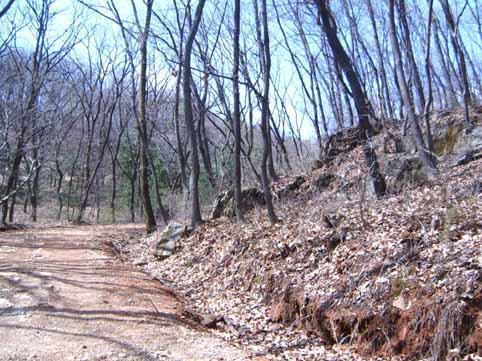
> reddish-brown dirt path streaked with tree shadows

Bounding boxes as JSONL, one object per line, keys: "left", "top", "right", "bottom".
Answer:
{"left": 0, "top": 225, "right": 248, "bottom": 361}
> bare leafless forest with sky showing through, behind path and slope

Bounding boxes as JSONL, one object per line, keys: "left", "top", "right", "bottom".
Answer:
{"left": 0, "top": 0, "right": 482, "bottom": 231}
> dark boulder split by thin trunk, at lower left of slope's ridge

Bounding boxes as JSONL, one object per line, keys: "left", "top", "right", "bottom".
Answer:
{"left": 211, "top": 188, "right": 265, "bottom": 219}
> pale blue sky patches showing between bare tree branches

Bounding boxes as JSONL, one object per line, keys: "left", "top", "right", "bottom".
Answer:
{"left": 0, "top": 0, "right": 482, "bottom": 141}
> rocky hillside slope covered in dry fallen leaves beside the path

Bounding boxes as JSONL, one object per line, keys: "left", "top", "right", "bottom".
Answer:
{"left": 124, "top": 109, "right": 482, "bottom": 360}
